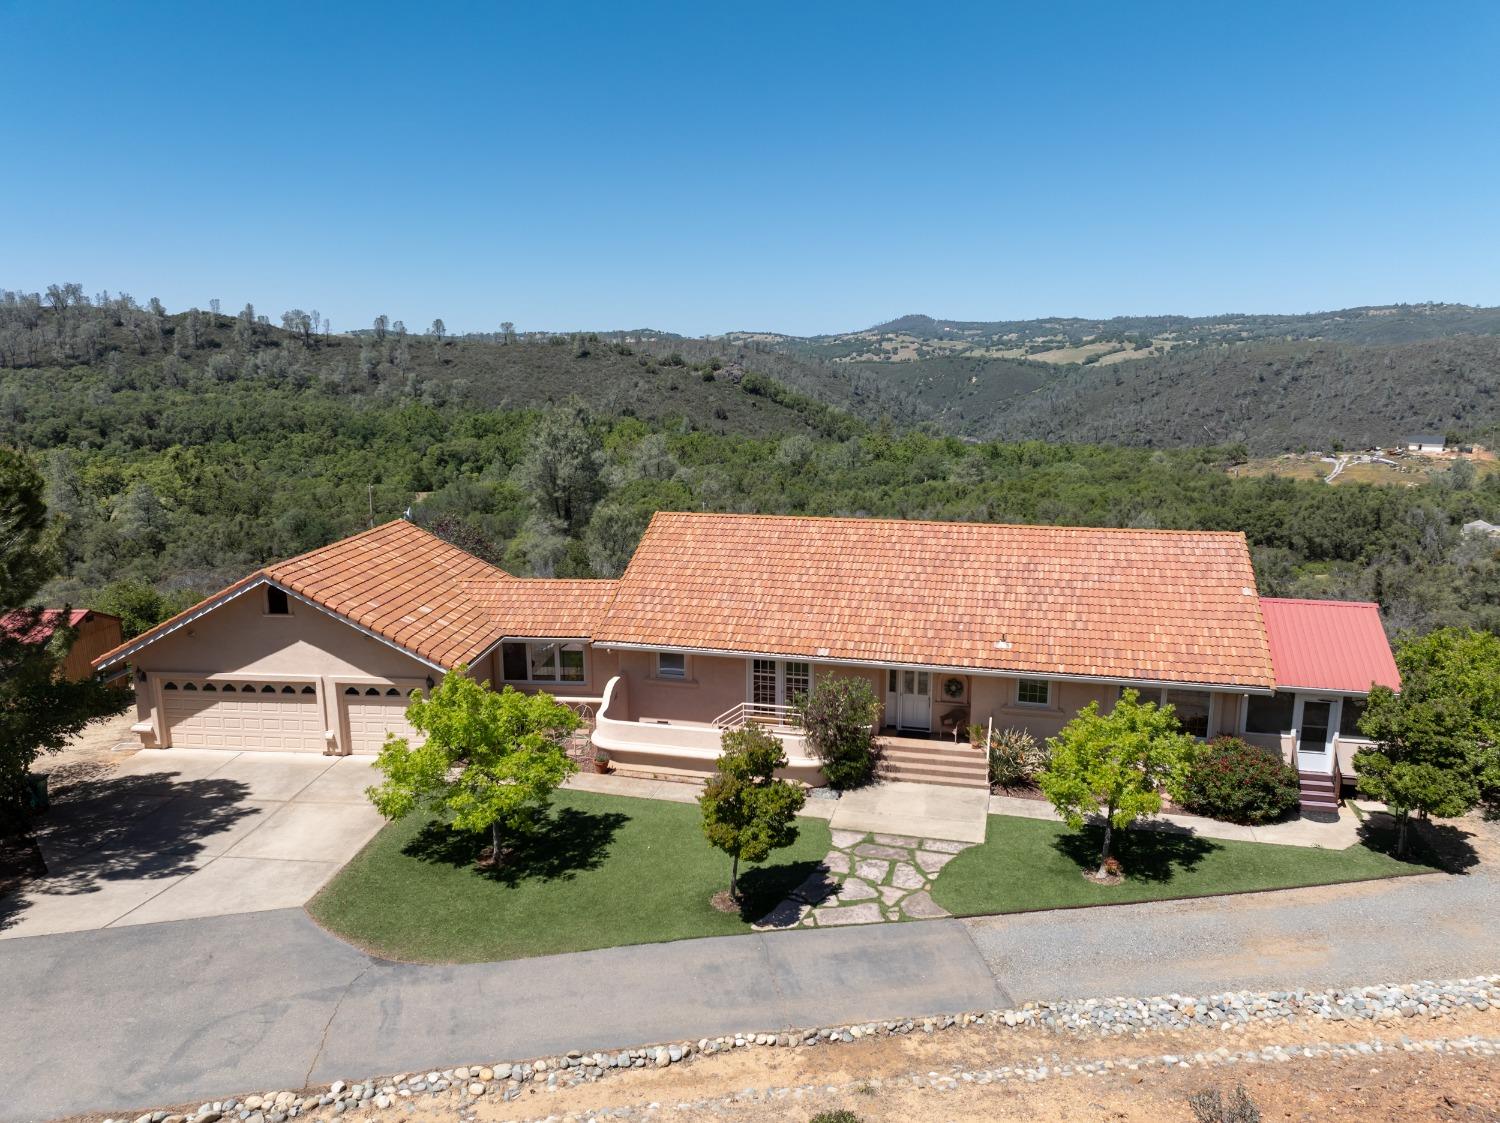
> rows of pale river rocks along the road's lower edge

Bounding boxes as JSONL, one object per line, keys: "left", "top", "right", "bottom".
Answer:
{"left": 105, "top": 975, "right": 1500, "bottom": 1123}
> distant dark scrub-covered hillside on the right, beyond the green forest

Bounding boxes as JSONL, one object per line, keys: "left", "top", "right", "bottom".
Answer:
{"left": 861, "top": 336, "right": 1500, "bottom": 453}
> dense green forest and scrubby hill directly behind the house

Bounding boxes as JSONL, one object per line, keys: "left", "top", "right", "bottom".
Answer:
{"left": 0, "top": 284, "right": 1500, "bottom": 644}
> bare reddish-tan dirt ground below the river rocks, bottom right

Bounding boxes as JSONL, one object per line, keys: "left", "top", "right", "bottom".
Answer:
{"left": 413, "top": 1011, "right": 1500, "bottom": 1123}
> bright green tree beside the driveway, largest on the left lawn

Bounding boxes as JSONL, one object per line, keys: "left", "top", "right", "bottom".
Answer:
{"left": 366, "top": 667, "right": 579, "bottom": 864}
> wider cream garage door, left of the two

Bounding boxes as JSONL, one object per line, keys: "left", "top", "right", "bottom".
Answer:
{"left": 162, "top": 679, "right": 324, "bottom": 753}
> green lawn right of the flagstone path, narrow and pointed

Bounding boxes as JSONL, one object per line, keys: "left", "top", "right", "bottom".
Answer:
{"left": 933, "top": 816, "right": 1434, "bottom": 916}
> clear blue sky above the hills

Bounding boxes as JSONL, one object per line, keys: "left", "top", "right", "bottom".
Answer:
{"left": 0, "top": 0, "right": 1500, "bottom": 334}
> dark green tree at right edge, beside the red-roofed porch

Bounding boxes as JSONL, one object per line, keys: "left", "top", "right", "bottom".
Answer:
{"left": 1355, "top": 628, "right": 1500, "bottom": 855}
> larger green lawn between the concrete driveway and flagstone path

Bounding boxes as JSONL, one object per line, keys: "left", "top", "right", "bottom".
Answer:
{"left": 308, "top": 792, "right": 830, "bottom": 963}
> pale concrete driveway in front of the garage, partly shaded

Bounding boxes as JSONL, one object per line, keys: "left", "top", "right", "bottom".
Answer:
{"left": 0, "top": 748, "right": 381, "bottom": 939}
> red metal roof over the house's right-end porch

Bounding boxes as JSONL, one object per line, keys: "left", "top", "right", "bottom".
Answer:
{"left": 1260, "top": 597, "right": 1401, "bottom": 694}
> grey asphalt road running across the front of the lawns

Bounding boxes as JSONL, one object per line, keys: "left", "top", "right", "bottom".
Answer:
{"left": 0, "top": 821, "right": 1500, "bottom": 1123}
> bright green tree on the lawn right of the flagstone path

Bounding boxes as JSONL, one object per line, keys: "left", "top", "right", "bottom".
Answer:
{"left": 1037, "top": 690, "right": 1197, "bottom": 876}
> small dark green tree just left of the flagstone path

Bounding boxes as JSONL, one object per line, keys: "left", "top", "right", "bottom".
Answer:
{"left": 698, "top": 726, "right": 807, "bottom": 901}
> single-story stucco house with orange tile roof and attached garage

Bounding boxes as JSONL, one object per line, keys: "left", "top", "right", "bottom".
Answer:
{"left": 98, "top": 511, "right": 1395, "bottom": 803}
